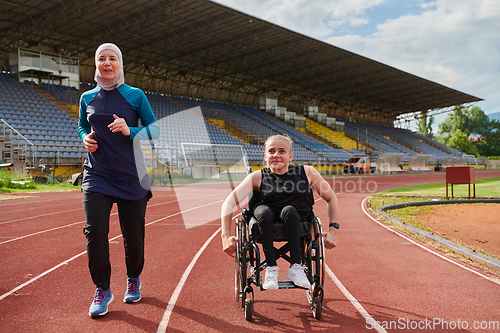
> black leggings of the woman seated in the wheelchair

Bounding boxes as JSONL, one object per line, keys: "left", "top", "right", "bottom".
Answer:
{"left": 254, "top": 205, "right": 302, "bottom": 266}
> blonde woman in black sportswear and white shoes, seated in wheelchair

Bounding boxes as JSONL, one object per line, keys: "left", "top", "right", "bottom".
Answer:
{"left": 221, "top": 135, "right": 338, "bottom": 289}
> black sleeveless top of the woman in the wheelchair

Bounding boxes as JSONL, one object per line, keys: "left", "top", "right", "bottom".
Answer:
{"left": 256, "top": 165, "right": 314, "bottom": 219}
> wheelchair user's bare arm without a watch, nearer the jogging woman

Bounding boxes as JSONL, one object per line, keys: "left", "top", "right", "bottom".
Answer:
{"left": 220, "top": 170, "right": 261, "bottom": 256}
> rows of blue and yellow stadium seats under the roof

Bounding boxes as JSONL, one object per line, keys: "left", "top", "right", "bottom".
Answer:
{"left": 0, "top": 73, "right": 461, "bottom": 170}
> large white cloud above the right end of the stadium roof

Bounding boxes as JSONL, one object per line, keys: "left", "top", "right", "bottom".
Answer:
{"left": 326, "top": 0, "right": 500, "bottom": 119}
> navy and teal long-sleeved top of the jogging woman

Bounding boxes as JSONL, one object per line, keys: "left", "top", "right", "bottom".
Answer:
{"left": 78, "top": 84, "right": 160, "bottom": 200}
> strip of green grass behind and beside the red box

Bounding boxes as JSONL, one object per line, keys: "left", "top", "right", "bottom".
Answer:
{"left": 380, "top": 177, "right": 500, "bottom": 197}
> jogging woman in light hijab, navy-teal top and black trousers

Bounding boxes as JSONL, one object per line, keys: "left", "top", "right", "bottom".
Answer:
{"left": 78, "top": 43, "right": 160, "bottom": 317}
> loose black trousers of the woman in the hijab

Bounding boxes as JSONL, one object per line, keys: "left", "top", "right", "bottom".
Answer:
{"left": 83, "top": 191, "right": 148, "bottom": 290}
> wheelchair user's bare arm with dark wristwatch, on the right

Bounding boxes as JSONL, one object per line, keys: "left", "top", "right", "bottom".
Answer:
{"left": 304, "top": 165, "right": 339, "bottom": 249}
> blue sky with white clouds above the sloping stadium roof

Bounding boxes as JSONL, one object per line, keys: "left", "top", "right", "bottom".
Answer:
{"left": 215, "top": 0, "right": 500, "bottom": 132}
